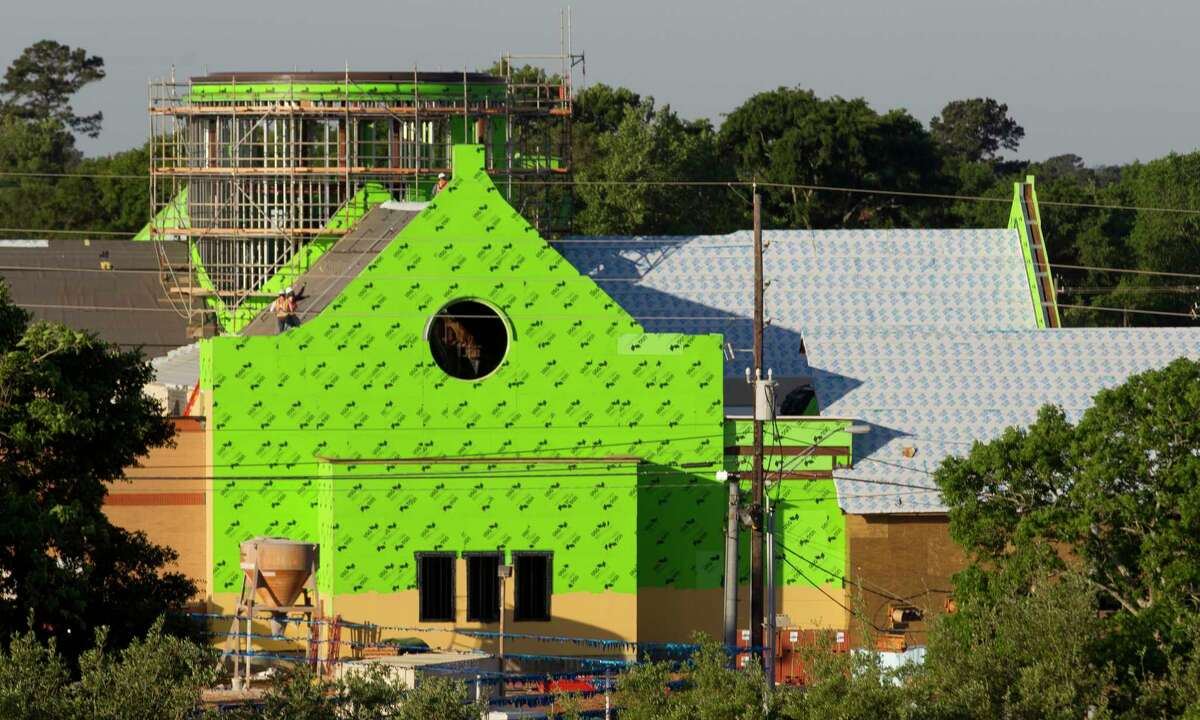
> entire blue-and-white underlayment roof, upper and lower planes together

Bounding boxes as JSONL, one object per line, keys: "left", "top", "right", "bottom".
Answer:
{"left": 558, "top": 229, "right": 1200, "bottom": 514}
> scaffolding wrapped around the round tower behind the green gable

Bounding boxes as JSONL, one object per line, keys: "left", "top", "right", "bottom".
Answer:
{"left": 150, "top": 33, "right": 582, "bottom": 335}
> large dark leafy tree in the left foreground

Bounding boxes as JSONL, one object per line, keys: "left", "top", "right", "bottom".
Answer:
{"left": 0, "top": 283, "right": 196, "bottom": 656}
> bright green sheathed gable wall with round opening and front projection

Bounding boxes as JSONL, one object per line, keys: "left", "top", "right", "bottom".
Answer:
{"left": 204, "top": 146, "right": 724, "bottom": 594}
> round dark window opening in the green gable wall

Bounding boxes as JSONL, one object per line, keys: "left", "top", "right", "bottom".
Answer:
{"left": 430, "top": 300, "right": 509, "bottom": 380}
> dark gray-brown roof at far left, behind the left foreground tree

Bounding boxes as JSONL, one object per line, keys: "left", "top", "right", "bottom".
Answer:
{"left": 0, "top": 240, "right": 190, "bottom": 358}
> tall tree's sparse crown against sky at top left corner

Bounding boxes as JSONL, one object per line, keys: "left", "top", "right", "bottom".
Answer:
{"left": 0, "top": 40, "right": 104, "bottom": 138}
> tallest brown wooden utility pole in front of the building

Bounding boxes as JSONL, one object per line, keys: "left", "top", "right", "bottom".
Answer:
{"left": 750, "top": 185, "right": 768, "bottom": 660}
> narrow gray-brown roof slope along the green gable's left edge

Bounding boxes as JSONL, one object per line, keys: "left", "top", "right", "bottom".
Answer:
{"left": 242, "top": 202, "right": 425, "bottom": 335}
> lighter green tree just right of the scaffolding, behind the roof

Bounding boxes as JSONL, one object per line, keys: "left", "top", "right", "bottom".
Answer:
{"left": 576, "top": 98, "right": 732, "bottom": 235}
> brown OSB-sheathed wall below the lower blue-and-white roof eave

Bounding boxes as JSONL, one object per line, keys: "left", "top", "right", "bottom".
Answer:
{"left": 846, "top": 515, "right": 965, "bottom": 644}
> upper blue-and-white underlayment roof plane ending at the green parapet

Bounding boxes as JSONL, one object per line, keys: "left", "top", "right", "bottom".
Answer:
{"left": 556, "top": 229, "right": 1037, "bottom": 377}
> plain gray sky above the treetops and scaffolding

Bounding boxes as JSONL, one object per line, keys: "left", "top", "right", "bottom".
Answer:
{"left": 0, "top": 0, "right": 1200, "bottom": 164}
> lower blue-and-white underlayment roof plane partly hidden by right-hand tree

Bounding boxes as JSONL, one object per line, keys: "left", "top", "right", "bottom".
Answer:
{"left": 805, "top": 328, "right": 1200, "bottom": 515}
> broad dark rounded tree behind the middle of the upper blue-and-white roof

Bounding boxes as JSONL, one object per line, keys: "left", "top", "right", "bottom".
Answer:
{"left": 720, "top": 88, "right": 942, "bottom": 228}
